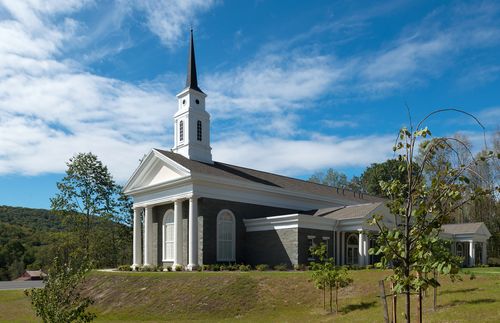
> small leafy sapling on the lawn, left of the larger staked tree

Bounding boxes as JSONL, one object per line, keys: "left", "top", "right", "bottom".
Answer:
{"left": 310, "top": 243, "right": 352, "bottom": 313}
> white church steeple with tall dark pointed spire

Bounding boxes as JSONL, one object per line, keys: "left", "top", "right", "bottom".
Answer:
{"left": 172, "top": 30, "right": 212, "bottom": 163}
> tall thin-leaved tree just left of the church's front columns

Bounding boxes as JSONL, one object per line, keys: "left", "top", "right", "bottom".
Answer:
{"left": 51, "top": 153, "right": 131, "bottom": 267}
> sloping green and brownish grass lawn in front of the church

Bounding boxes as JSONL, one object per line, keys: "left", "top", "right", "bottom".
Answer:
{"left": 0, "top": 268, "right": 500, "bottom": 322}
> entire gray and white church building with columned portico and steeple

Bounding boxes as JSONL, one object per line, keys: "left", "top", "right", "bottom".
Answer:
{"left": 124, "top": 32, "right": 490, "bottom": 270}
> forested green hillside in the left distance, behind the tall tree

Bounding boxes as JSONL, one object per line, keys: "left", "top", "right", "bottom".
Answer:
{"left": 0, "top": 206, "right": 131, "bottom": 280}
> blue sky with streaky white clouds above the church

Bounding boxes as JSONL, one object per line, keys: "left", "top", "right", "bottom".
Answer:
{"left": 0, "top": 0, "right": 500, "bottom": 208}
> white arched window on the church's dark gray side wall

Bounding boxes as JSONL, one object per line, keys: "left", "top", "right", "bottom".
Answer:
{"left": 217, "top": 210, "right": 236, "bottom": 261}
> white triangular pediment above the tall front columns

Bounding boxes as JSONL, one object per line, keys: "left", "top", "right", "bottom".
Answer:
{"left": 123, "top": 149, "right": 190, "bottom": 193}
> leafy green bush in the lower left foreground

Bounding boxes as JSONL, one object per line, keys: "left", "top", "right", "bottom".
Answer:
{"left": 25, "top": 258, "right": 96, "bottom": 323}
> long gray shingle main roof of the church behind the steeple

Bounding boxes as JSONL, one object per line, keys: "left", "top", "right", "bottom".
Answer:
{"left": 155, "top": 149, "right": 384, "bottom": 204}
